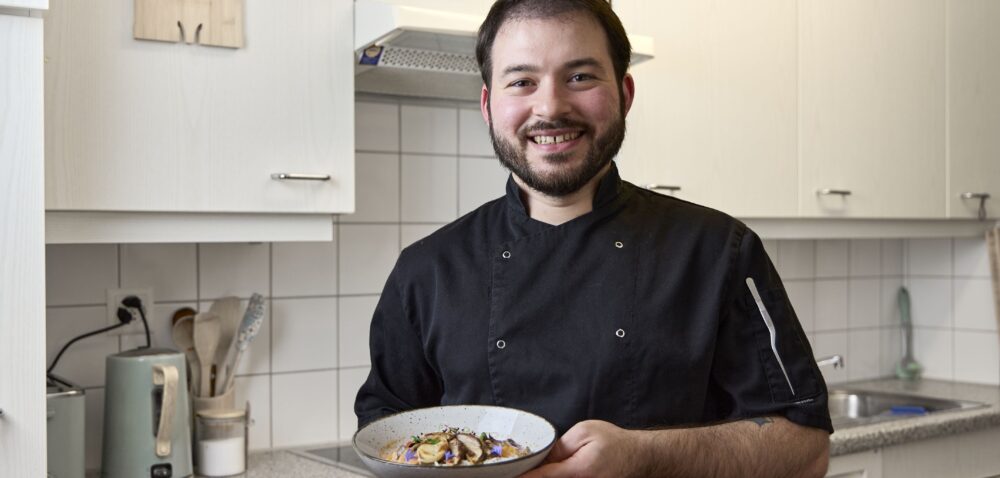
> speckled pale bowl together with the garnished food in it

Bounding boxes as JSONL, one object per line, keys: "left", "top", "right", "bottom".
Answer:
{"left": 353, "top": 405, "right": 556, "bottom": 478}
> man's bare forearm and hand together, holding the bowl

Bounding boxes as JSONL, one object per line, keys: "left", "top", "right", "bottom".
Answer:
{"left": 521, "top": 417, "right": 830, "bottom": 478}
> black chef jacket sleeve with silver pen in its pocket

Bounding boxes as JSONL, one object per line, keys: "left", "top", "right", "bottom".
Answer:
{"left": 708, "top": 226, "right": 833, "bottom": 433}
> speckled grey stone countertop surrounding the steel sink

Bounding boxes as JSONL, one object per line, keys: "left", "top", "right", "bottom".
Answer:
{"left": 829, "top": 378, "right": 1000, "bottom": 456}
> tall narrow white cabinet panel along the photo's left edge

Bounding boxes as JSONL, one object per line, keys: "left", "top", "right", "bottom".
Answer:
{"left": 0, "top": 5, "right": 45, "bottom": 477}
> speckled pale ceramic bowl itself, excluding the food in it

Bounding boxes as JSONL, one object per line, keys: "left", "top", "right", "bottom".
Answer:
{"left": 353, "top": 405, "right": 556, "bottom": 478}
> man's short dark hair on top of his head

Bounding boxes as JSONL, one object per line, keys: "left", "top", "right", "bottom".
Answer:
{"left": 476, "top": 0, "right": 632, "bottom": 89}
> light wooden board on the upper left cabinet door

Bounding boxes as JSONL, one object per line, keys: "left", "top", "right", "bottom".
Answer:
{"left": 132, "top": 0, "right": 244, "bottom": 48}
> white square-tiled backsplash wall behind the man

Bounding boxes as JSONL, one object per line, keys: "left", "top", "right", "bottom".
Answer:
{"left": 47, "top": 98, "right": 1000, "bottom": 468}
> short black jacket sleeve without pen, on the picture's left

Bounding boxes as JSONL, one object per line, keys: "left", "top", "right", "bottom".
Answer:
{"left": 354, "top": 263, "right": 442, "bottom": 427}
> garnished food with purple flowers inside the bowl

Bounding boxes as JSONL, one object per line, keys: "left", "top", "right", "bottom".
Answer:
{"left": 382, "top": 428, "right": 531, "bottom": 466}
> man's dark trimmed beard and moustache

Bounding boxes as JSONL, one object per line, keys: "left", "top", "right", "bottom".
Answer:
{"left": 489, "top": 111, "right": 625, "bottom": 197}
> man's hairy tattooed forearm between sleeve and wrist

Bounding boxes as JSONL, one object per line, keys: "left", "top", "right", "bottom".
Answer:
{"left": 639, "top": 417, "right": 830, "bottom": 478}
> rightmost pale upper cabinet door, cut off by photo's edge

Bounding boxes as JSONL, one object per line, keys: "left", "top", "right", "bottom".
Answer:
{"left": 947, "top": 0, "right": 1000, "bottom": 218}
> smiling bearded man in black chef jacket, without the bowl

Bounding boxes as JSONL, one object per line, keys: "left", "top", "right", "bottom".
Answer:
{"left": 355, "top": 0, "right": 832, "bottom": 477}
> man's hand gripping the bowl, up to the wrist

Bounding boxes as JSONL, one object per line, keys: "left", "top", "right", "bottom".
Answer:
{"left": 521, "top": 420, "right": 644, "bottom": 478}
